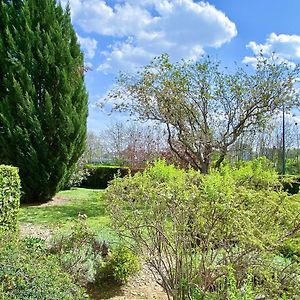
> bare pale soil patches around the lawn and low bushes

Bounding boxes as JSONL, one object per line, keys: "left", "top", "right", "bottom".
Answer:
{"left": 20, "top": 197, "right": 168, "bottom": 300}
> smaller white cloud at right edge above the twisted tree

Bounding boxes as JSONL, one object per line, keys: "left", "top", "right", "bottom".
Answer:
{"left": 243, "top": 33, "right": 300, "bottom": 65}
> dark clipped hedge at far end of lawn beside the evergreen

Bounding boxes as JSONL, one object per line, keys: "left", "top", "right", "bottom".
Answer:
{"left": 80, "top": 165, "right": 129, "bottom": 189}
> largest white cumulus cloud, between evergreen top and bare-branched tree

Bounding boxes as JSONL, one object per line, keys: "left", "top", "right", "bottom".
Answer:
{"left": 70, "top": 0, "right": 237, "bottom": 73}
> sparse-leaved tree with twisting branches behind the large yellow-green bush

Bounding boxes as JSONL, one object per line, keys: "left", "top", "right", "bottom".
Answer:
{"left": 108, "top": 55, "right": 299, "bottom": 173}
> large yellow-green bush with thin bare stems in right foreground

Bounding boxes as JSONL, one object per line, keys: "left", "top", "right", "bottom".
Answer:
{"left": 105, "top": 160, "right": 300, "bottom": 299}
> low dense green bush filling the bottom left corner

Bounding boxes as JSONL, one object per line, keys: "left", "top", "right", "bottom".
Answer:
{"left": 0, "top": 234, "right": 88, "bottom": 300}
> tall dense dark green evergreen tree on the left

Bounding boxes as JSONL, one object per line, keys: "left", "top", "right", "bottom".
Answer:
{"left": 0, "top": 0, "right": 87, "bottom": 202}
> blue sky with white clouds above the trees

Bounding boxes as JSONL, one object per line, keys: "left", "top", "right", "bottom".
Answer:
{"left": 62, "top": 0, "right": 300, "bottom": 133}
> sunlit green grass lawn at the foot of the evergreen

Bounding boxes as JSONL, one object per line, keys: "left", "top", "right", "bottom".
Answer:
{"left": 19, "top": 188, "right": 115, "bottom": 238}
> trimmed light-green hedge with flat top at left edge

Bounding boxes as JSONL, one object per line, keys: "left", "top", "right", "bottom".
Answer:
{"left": 0, "top": 165, "right": 20, "bottom": 231}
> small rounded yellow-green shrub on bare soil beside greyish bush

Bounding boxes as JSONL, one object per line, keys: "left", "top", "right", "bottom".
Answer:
{"left": 102, "top": 245, "right": 141, "bottom": 283}
